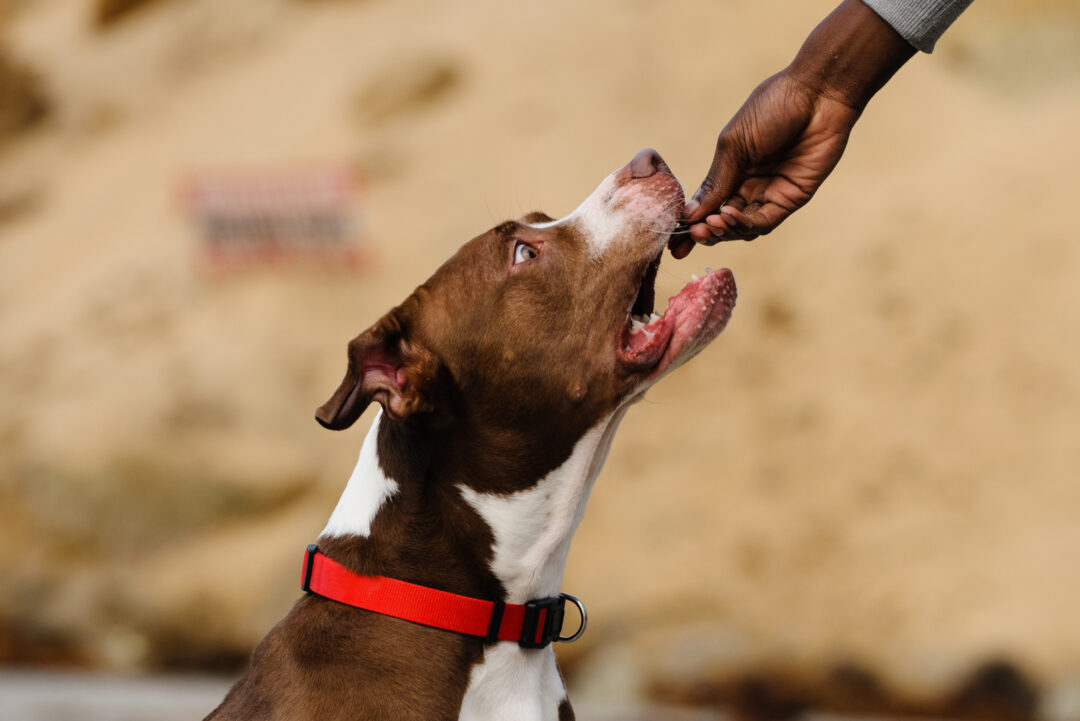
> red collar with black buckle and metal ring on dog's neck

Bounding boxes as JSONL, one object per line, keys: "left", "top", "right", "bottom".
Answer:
{"left": 300, "top": 544, "right": 586, "bottom": 649}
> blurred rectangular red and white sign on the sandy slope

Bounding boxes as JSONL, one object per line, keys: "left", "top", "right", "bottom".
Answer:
{"left": 184, "top": 166, "right": 366, "bottom": 270}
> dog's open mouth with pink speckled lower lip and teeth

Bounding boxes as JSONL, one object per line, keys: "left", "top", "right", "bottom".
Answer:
{"left": 619, "top": 250, "right": 737, "bottom": 373}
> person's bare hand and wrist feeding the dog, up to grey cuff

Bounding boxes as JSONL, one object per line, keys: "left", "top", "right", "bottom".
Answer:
{"left": 669, "top": 0, "right": 915, "bottom": 258}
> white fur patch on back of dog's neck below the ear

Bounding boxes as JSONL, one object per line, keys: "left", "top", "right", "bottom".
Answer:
{"left": 319, "top": 409, "right": 397, "bottom": 538}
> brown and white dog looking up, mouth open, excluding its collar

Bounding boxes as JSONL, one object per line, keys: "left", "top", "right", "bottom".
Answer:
{"left": 207, "top": 150, "right": 735, "bottom": 721}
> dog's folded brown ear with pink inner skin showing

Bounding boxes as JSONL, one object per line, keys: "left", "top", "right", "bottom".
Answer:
{"left": 315, "top": 311, "right": 440, "bottom": 431}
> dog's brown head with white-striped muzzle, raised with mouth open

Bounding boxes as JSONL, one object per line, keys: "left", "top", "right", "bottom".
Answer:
{"left": 315, "top": 150, "right": 735, "bottom": 440}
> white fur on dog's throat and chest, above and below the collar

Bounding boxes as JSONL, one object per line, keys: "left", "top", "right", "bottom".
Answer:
{"left": 460, "top": 405, "right": 629, "bottom": 721}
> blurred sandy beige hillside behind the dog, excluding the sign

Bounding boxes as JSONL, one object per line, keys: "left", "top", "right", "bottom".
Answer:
{"left": 0, "top": 0, "right": 1080, "bottom": 720}
